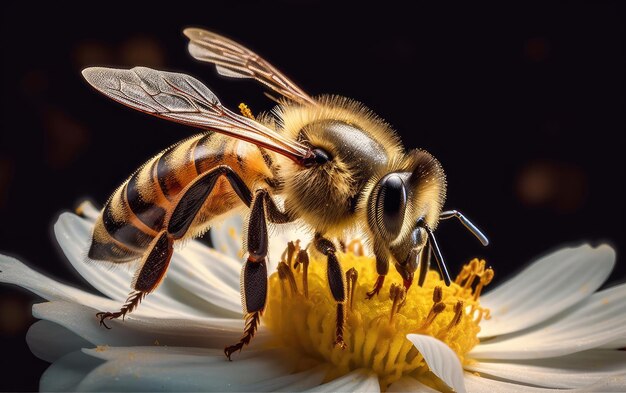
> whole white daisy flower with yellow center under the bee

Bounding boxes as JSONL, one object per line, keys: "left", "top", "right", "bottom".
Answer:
{"left": 0, "top": 204, "right": 626, "bottom": 392}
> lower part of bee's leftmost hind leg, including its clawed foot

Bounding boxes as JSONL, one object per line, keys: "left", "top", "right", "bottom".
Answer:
{"left": 96, "top": 231, "right": 174, "bottom": 329}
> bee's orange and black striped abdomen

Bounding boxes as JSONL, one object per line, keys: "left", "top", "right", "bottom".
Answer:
{"left": 89, "top": 133, "right": 272, "bottom": 262}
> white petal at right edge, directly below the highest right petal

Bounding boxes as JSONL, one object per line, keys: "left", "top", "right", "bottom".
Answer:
{"left": 469, "top": 284, "right": 626, "bottom": 359}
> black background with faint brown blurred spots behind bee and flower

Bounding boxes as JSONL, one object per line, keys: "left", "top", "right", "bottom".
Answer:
{"left": 0, "top": 1, "right": 626, "bottom": 390}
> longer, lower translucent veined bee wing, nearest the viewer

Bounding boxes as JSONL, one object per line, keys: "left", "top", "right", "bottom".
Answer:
{"left": 83, "top": 67, "right": 311, "bottom": 162}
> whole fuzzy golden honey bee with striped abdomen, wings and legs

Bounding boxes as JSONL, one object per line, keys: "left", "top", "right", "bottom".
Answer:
{"left": 82, "top": 28, "right": 488, "bottom": 359}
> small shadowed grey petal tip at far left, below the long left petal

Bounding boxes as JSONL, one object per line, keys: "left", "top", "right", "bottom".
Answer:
{"left": 26, "top": 321, "right": 93, "bottom": 363}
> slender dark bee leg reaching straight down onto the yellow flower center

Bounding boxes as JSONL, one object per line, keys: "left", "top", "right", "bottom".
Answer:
{"left": 313, "top": 233, "right": 346, "bottom": 349}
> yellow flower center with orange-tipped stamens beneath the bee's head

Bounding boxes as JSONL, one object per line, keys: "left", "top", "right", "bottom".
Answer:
{"left": 264, "top": 240, "right": 493, "bottom": 389}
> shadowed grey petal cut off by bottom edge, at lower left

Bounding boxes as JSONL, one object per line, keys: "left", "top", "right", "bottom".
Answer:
{"left": 39, "top": 351, "right": 102, "bottom": 392}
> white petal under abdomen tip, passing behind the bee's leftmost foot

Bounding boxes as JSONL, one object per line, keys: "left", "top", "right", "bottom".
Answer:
{"left": 54, "top": 213, "right": 240, "bottom": 318}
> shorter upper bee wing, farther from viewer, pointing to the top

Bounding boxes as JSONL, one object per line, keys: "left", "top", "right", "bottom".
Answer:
{"left": 183, "top": 28, "right": 316, "bottom": 104}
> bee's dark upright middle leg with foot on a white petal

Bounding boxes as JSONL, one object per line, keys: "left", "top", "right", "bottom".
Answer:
{"left": 224, "top": 190, "right": 271, "bottom": 360}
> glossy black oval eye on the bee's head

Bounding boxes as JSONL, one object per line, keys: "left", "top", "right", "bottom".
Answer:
{"left": 376, "top": 173, "right": 407, "bottom": 239}
